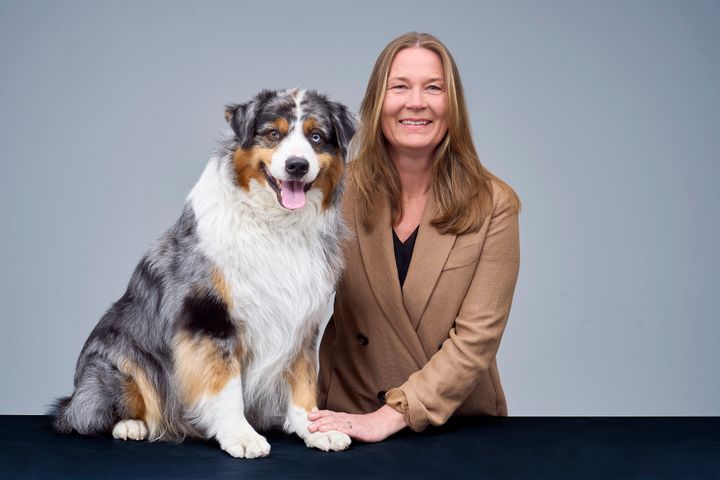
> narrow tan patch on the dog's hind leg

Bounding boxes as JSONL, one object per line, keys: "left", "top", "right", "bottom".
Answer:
{"left": 119, "top": 359, "right": 163, "bottom": 438}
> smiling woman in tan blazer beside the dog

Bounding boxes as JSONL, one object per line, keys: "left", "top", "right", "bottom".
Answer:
{"left": 309, "top": 33, "right": 519, "bottom": 442}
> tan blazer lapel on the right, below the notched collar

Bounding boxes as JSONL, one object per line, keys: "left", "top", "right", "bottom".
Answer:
{"left": 402, "top": 192, "right": 456, "bottom": 330}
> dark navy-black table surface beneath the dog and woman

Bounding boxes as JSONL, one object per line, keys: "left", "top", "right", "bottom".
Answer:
{"left": 0, "top": 416, "right": 720, "bottom": 480}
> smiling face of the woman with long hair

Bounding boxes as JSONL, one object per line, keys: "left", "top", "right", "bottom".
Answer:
{"left": 380, "top": 47, "right": 448, "bottom": 158}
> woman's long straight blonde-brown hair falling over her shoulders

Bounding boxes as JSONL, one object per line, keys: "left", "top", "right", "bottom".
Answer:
{"left": 350, "top": 32, "right": 520, "bottom": 234}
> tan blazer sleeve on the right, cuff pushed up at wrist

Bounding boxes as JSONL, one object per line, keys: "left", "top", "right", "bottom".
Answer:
{"left": 385, "top": 188, "right": 520, "bottom": 431}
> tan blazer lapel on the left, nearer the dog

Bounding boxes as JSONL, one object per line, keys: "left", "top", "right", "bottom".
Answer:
{"left": 353, "top": 195, "right": 427, "bottom": 368}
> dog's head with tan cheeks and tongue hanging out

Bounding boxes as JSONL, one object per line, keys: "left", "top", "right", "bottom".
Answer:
{"left": 225, "top": 90, "right": 356, "bottom": 210}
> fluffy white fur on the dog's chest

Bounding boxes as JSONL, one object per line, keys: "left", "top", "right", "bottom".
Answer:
{"left": 189, "top": 159, "right": 340, "bottom": 397}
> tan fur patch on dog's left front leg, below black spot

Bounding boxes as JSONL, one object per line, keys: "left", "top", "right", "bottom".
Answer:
{"left": 174, "top": 332, "right": 241, "bottom": 406}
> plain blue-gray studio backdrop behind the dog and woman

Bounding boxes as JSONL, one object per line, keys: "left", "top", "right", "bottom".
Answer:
{"left": 0, "top": 0, "right": 720, "bottom": 415}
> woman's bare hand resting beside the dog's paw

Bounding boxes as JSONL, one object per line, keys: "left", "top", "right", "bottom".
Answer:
{"left": 308, "top": 405, "right": 407, "bottom": 442}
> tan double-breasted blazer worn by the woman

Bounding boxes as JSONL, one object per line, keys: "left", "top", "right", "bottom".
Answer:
{"left": 319, "top": 178, "right": 520, "bottom": 431}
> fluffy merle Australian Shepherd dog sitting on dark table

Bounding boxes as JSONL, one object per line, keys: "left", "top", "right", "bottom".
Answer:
{"left": 51, "top": 89, "right": 356, "bottom": 458}
